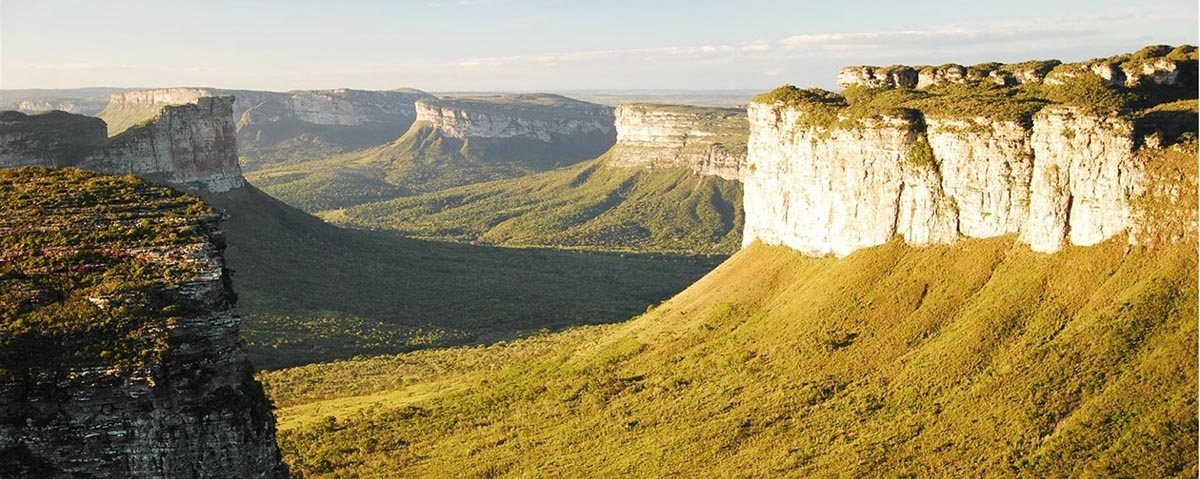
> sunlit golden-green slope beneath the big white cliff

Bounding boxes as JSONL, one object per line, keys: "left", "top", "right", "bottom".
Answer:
{"left": 263, "top": 236, "right": 1198, "bottom": 478}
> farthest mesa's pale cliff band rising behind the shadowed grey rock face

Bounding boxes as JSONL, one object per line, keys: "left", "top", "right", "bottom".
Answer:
{"left": 100, "top": 88, "right": 432, "bottom": 136}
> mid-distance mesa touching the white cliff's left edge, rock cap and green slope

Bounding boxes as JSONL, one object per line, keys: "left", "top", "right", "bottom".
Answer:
{"left": 313, "top": 104, "right": 749, "bottom": 253}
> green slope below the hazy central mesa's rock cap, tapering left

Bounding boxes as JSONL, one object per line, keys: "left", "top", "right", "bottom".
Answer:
{"left": 246, "top": 112, "right": 614, "bottom": 212}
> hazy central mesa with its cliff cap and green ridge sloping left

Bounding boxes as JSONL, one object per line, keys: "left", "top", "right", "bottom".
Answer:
{"left": 247, "top": 95, "right": 616, "bottom": 211}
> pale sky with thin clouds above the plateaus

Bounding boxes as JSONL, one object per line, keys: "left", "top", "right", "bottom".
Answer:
{"left": 0, "top": 0, "right": 1198, "bottom": 91}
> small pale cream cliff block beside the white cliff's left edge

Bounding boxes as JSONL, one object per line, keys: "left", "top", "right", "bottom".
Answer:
{"left": 607, "top": 103, "right": 750, "bottom": 180}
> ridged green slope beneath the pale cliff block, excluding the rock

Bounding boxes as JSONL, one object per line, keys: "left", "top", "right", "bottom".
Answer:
{"left": 326, "top": 158, "right": 742, "bottom": 253}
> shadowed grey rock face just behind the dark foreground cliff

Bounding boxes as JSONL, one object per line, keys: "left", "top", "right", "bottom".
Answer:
{"left": 0, "top": 97, "right": 245, "bottom": 193}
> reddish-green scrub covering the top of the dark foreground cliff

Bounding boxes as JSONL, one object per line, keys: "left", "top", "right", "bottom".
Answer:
{"left": 0, "top": 168, "right": 215, "bottom": 375}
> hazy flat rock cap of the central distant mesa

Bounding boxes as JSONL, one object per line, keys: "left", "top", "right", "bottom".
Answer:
{"left": 416, "top": 95, "right": 613, "bottom": 143}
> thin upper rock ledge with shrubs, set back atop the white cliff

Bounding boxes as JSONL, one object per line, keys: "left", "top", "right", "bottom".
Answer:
{"left": 838, "top": 46, "right": 1196, "bottom": 89}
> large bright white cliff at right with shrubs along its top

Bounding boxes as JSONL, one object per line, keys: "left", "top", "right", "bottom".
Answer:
{"left": 743, "top": 47, "right": 1196, "bottom": 256}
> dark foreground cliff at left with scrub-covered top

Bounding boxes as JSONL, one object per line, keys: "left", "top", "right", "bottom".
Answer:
{"left": 0, "top": 168, "right": 287, "bottom": 478}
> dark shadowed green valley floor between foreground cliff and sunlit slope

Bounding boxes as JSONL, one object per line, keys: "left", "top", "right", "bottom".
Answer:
{"left": 205, "top": 187, "right": 721, "bottom": 369}
